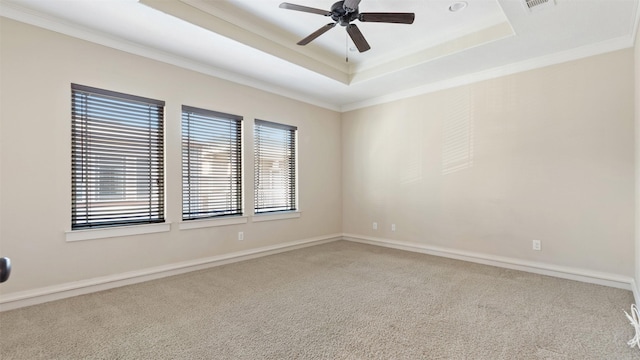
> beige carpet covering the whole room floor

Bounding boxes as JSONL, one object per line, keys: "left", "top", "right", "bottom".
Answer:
{"left": 0, "top": 241, "right": 640, "bottom": 360}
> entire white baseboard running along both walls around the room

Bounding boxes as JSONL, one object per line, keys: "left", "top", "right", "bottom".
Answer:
{"left": 0, "top": 234, "right": 640, "bottom": 311}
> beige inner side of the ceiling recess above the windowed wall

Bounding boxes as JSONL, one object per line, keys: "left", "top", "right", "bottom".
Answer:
{"left": 139, "top": 0, "right": 349, "bottom": 84}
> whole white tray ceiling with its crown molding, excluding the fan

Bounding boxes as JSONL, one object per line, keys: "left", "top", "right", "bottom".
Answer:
{"left": 0, "top": 0, "right": 639, "bottom": 111}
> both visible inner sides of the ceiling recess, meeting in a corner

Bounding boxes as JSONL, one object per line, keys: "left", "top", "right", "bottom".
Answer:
{"left": 144, "top": 0, "right": 515, "bottom": 85}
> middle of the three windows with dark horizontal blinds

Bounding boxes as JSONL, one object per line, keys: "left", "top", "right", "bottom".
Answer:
{"left": 182, "top": 106, "right": 242, "bottom": 220}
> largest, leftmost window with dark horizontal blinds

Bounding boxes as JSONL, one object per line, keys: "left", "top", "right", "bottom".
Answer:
{"left": 71, "top": 84, "right": 164, "bottom": 230}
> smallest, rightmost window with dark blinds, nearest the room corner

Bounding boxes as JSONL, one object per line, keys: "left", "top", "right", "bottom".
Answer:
{"left": 254, "top": 120, "right": 297, "bottom": 213}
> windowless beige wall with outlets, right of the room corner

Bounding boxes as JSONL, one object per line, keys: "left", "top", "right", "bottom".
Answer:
{"left": 342, "top": 49, "right": 634, "bottom": 277}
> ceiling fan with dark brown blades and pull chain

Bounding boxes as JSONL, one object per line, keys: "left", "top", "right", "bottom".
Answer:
{"left": 280, "top": 0, "right": 415, "bottom": 52}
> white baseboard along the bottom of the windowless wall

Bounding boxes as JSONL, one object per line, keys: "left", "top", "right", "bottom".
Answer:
{"left": 342, "top": 234, "right": 638, "bottom": 292}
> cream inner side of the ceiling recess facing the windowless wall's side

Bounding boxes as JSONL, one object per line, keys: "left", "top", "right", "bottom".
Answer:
{"left": 349, "top": 21, "right": 515, "bottom": 84}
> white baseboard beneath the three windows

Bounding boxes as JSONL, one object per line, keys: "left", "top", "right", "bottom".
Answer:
{"left": 0, "top": 234, "right": 342, "bottom": 311}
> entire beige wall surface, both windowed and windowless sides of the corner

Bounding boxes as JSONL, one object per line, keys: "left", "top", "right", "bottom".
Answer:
{"left": 0, "top": 18, "right": 640, "bottom": 295}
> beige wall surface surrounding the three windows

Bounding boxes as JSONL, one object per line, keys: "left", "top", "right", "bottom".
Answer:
{"left": 0, "top": 18, "right": 342, "bottom": 295}
